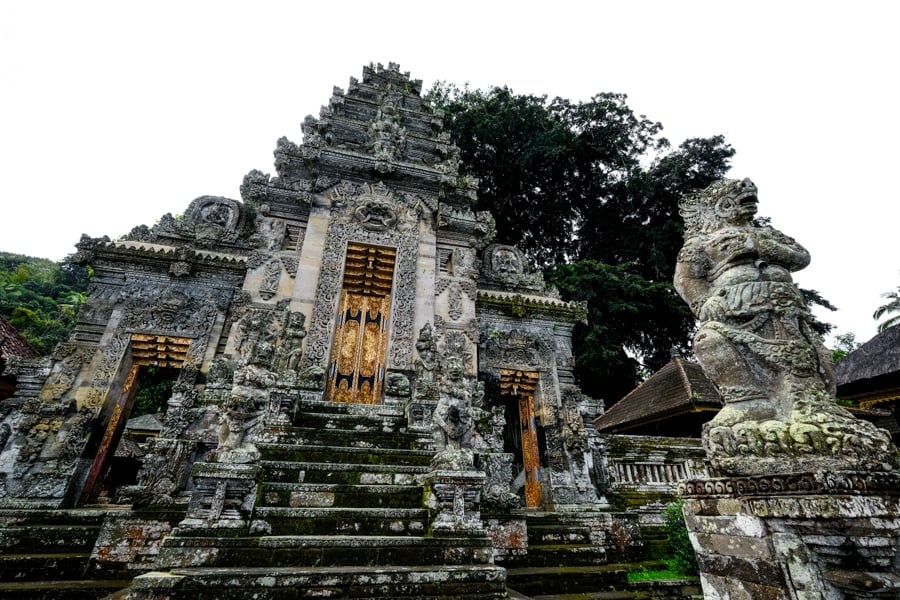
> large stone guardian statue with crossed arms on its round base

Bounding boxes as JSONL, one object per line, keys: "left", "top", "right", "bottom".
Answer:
{"left": 674, "top": 179, "right": 898, "bottom": 475}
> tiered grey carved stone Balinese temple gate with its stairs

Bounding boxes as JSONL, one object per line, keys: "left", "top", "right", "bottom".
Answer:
{"left": 0, "top": 64, "right": 700, "bottom": 600}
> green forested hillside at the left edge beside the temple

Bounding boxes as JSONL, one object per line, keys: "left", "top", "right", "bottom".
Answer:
{"left": 0, "top": 252, "right": 90, "bottom": 354}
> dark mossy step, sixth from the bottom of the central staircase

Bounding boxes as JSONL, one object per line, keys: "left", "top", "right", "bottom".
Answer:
{"left": 257, "top": 443, "right": 434, "bottom": 466}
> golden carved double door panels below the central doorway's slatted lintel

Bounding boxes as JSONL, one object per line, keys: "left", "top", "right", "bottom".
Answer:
{"left": 325, "top": 290, "right": 391, "bottom": 404}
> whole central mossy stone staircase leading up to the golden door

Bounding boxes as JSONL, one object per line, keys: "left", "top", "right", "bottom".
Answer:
{"left": 128, "top": 402, "right": 506, "bottom": 600}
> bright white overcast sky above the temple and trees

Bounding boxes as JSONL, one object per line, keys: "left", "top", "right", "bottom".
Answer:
{"left": 0, "top": 0, "right": 900, "bottom": 341}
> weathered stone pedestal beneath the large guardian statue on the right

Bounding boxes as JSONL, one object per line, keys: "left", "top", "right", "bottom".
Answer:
{"left": 680, "top": 471, "right": 900, "bottom": 600}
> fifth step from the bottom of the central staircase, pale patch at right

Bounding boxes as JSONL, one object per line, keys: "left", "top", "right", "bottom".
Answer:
{"left": 260, "top": 460, "right": 430, "bottom": 485}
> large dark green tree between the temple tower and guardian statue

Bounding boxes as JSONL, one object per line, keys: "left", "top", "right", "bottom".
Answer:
{"left": 430, "top": 84, "right": 734, "bottom": 404}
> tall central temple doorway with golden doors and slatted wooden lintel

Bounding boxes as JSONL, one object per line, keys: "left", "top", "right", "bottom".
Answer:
{"left": 325, "top": 243, "right": 397, "bottom": 404}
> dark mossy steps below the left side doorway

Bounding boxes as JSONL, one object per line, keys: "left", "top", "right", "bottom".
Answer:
{"left": 0, "top": 509, "right": 130, "bottom": 600}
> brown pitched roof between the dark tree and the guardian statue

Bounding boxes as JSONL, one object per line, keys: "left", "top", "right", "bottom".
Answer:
{"left": 594, "top": 358, "right": 722, "bottom": 433}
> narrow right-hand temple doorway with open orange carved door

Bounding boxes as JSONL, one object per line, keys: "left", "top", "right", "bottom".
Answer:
{"left": 500, "top": 369, "right": 543, "bottom": 508}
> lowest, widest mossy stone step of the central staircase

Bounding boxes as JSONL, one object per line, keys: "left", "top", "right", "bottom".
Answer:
{"left": 129, "top": 565, "right": 506, "bottom": 600}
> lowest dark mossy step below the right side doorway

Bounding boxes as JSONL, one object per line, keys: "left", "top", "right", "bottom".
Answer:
{"left": 506, "top": 565, "right": 628, "bottom": 596}
